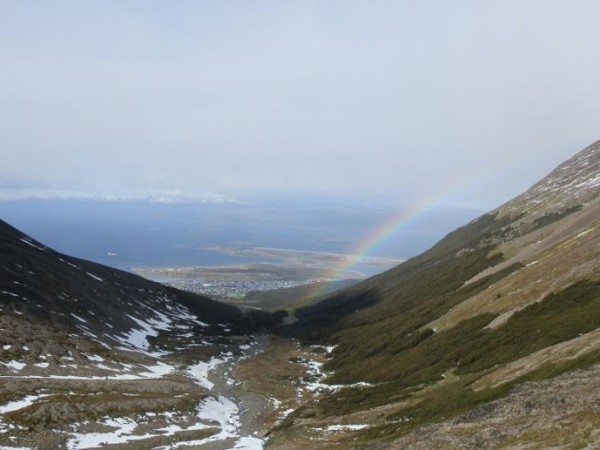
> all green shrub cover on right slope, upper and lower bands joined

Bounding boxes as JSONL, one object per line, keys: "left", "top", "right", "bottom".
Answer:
{"left": 291, "top": 215, "right": 600, "bottom": 386}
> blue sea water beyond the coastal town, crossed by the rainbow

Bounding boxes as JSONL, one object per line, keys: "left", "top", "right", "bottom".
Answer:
{"left": 0, "top": 199, "right": 480, "bottom": 275}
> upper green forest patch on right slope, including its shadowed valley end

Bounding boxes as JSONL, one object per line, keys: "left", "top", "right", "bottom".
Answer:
{"left": 288, "top": 214, "right": 522, "bottom": 383}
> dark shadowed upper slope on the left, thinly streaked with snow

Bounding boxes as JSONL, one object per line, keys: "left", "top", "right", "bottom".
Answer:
{"left": 0, "top": 217, "right": 284, "bottom": 334}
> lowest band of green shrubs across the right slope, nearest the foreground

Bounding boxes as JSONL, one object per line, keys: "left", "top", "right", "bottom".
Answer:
{"left": 292, "top": 281, "right": 600, "bottom": 440}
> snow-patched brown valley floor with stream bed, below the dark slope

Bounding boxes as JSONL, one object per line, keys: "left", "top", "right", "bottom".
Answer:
{"left": 0, "top": 316, "right": 344, "bottom": 450}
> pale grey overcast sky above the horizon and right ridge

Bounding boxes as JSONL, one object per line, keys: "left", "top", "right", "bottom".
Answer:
{"left": 0, "top": 0, "right": 600, "bottom": 209}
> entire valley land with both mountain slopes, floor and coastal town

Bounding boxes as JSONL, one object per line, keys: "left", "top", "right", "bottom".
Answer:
{"left": 0, "top": 141, "right": 600, "bottom": 450}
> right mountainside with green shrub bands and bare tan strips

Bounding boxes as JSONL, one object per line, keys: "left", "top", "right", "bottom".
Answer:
{"left": 276, "top": 141, "right": 600, "bottom": 446}
